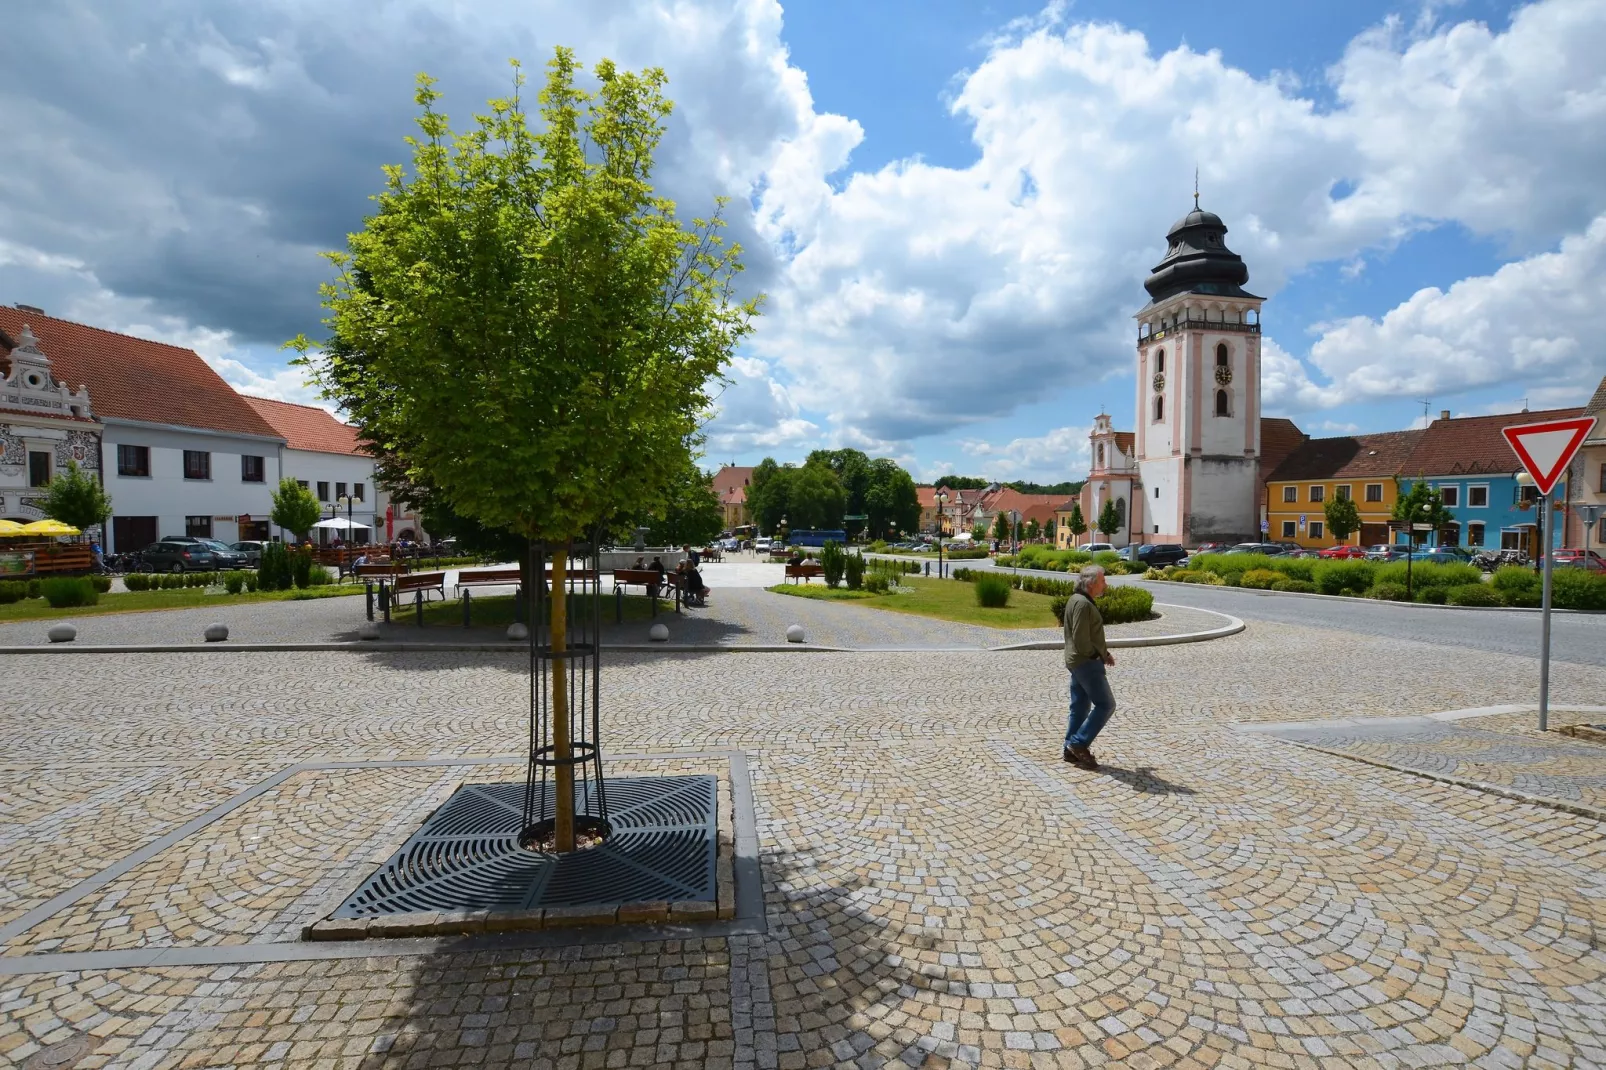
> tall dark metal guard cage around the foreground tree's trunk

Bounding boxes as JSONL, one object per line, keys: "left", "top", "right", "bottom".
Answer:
{"left": 519, "top": 538, "right": 612, "bottom": 853}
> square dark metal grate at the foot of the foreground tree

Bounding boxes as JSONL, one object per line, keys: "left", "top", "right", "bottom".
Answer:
{"left": 332, "top": 776, "right": 718, "bottom": 917}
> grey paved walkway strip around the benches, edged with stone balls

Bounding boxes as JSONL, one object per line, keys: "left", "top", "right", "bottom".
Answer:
{"left": 0, "top": 578, "right": 1225, "bottom": 649}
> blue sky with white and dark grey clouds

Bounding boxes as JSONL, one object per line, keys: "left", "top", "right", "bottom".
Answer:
{"left": 0, "top": 0, "right": 1606, "bottom": 482}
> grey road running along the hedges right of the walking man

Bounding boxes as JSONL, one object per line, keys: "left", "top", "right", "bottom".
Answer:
{"left": 886, "top": 554, "right": 1606, "bottom": 665}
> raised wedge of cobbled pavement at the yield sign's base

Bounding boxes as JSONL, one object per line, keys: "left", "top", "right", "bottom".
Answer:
{"left": 1246, "top": 712, "right": 1606, "bottom": 811}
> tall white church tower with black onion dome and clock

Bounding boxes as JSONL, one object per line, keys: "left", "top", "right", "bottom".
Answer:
{"left": 1135, "top": 193, "right": 1264, "bottom": 546}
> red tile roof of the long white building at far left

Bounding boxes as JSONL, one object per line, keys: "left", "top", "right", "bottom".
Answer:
{"left": 0, "top": 305, "right": 279, "bottom": 439}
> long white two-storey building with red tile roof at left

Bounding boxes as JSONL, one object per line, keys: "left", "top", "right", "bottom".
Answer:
{"left": 0, "top": 307, "right": 284, "bottom": 553}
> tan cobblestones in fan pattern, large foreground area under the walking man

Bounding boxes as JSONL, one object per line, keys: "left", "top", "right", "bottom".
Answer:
{"left": 0, "top": 625, "right": 1606, "bottom": 1070}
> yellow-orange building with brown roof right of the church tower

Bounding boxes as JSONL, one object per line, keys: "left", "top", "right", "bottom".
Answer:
{"left": 1266, "top": 431, "right": 1423, "bottom": 549}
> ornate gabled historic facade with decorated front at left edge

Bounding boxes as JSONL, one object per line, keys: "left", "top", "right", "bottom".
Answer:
{"left": 0, "top": 325, "right": 101, "bottom": 523}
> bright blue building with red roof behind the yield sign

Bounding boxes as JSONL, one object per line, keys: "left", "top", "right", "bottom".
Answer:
{"left": 1399, "top": 408, "right": 1582, "bottom": 557}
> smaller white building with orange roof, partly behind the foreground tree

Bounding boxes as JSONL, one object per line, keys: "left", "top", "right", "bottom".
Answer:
{"left": 243, "top": 395, "right": 375, "bottom": 543}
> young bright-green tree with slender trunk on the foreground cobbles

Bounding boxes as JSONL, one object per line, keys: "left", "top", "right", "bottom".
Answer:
{"left": 294, "top": 48, "right": 758, "bottom": 852}
